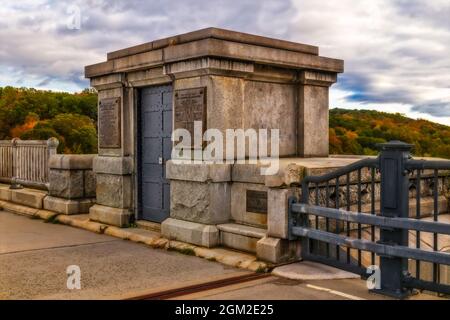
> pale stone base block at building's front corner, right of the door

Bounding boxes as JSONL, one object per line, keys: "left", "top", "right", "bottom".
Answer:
{"left": 161, "top": 218, "right": 219, "bottom": 248}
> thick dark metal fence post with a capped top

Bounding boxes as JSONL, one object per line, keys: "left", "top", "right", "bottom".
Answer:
{"left": 374, "top": 141, "right": 412, "bottom": 298}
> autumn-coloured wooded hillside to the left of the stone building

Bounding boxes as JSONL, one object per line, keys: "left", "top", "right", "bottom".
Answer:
{"left": 0, "top": 87, "right": 97, "bottom": 153}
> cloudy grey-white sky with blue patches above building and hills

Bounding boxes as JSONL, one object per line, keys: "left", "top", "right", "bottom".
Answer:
{"left": 0, "top": 0, "right": 450, "bottom": 125}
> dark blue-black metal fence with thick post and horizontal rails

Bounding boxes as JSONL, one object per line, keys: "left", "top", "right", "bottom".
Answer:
{"left": 289, "top": 141, "right": 450, "bottom": 298}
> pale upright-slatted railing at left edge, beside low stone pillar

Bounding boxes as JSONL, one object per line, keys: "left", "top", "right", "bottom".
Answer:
{"left": 0, "top": 138, "right": 59, "bottom": 189}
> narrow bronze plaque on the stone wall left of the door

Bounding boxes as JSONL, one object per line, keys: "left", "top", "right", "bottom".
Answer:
{"left": 98, "top": 98, "right": 121, "bottom": 148}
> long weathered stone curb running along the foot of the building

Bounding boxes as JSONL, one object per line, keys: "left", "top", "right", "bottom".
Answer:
{"left": 0, "top": 200, "right": 273, "bottom": 272}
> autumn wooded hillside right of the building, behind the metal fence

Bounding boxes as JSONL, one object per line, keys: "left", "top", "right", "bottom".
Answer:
{"left": 330, "top": 109, "right": 450, "bottom": 158}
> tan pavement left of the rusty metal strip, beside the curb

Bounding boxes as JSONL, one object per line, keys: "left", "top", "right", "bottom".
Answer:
{"left": 0, "top": 212, "right": 246, "bottom": 299}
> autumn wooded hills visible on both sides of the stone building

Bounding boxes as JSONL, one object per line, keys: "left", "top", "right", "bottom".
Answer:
{"left": 0, "top": 87, "right": 450, "bottom": 158}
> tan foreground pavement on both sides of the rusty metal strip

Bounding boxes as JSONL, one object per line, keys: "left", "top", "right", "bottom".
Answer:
{"left": 0, "top": 211, "right": 442, "bottom": 300}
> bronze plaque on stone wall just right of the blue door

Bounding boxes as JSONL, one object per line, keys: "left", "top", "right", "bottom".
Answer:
{"left": 174, "top": 88, "right": 206, "bottom": 142}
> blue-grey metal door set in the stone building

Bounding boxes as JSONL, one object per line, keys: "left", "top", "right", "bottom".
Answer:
{"left": 139, "top": 85, "right": 173, "bottom": 222}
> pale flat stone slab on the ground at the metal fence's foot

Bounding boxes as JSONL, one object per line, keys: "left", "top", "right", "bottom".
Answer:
{"left": 272, "top": 261, "right": 361, "bottom": 280}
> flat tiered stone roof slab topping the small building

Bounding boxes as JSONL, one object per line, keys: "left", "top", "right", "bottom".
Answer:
{"left": 85, "top": 28, "right": 344, "bottom": 78}
